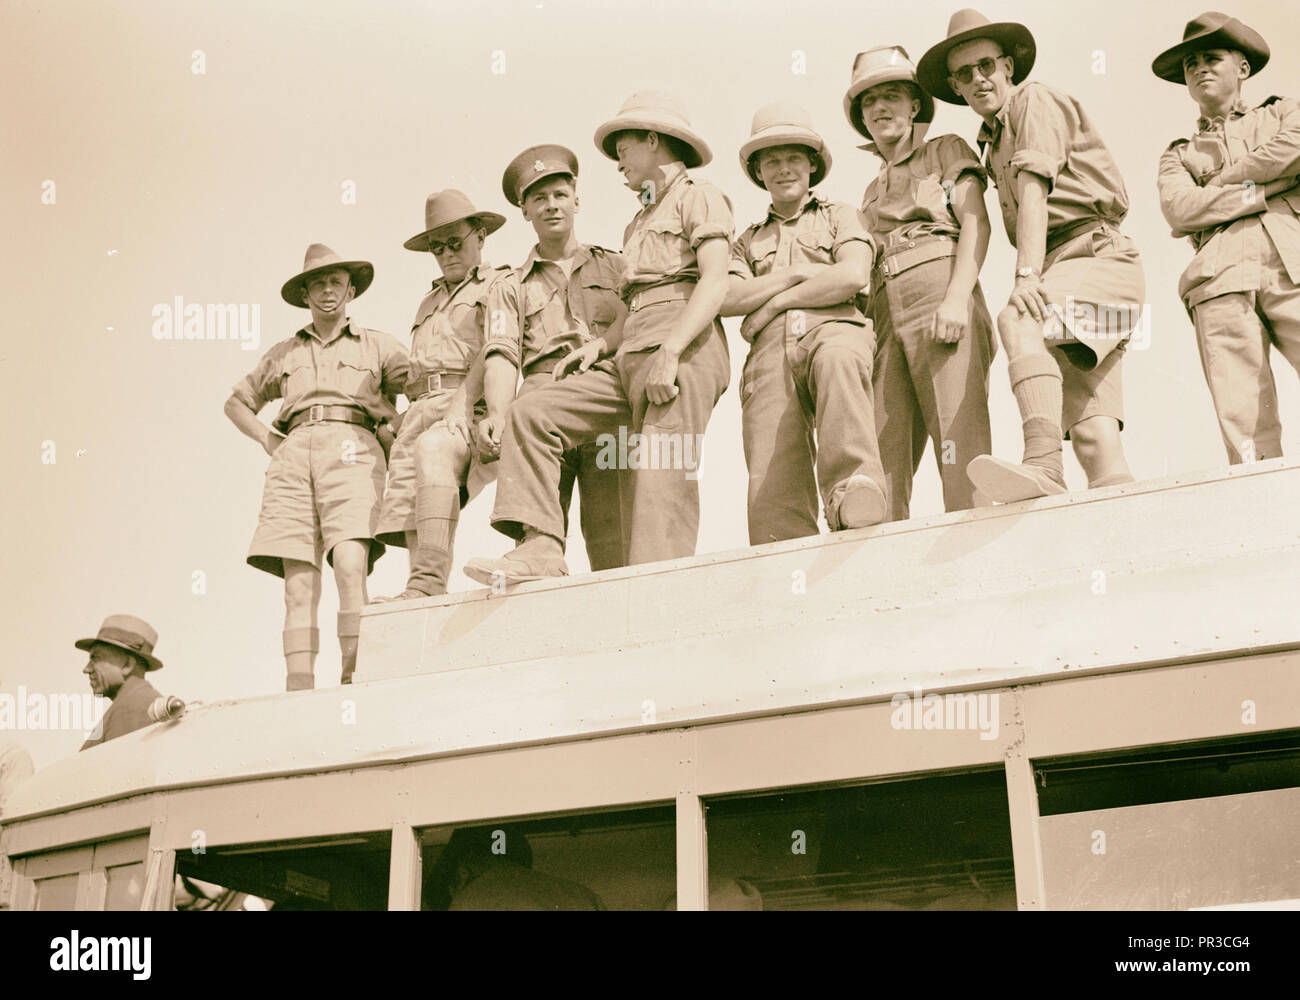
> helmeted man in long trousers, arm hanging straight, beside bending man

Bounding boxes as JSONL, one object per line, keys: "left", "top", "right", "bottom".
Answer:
{"left": 844, "top": 46, "right": 997, "bottom": 520}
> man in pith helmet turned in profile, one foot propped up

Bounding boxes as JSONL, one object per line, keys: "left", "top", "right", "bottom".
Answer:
{"left": 465, "top": 91, "right": 733, "bottom": 584}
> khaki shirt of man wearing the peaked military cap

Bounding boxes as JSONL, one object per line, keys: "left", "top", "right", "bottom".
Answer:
{"left": 486, "top": 244, "right": 623, "bottom": 372}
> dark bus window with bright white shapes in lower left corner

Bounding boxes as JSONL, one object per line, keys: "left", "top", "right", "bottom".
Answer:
{"left": 176, "top": 831, "right": 391, "bottom": 910}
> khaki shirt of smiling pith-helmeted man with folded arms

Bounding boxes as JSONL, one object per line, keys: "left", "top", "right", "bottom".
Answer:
{"left": 731, "top": 194, "right": 876, "bottom": 332}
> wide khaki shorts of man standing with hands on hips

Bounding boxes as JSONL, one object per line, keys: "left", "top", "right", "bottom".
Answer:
{"left": 248, "top": 421, "right": 385, "bottom": 576}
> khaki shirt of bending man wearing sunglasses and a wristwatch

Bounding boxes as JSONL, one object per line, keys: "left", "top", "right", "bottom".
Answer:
{"left": 979, "top": 83, "right": 1128, "bottom": 247}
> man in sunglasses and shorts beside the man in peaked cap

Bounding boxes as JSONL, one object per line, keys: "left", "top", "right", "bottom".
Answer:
{"left": 376, "top": 190, "right": 510, "bottom": 601}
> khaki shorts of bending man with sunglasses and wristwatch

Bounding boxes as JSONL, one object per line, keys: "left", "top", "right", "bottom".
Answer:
{"left": 1043, "top": 224, "right": 1147, "bottom": 438}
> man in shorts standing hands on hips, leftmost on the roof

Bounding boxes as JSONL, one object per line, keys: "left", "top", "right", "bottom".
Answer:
{"left": 226, "top": 243, "right": 410, "bottom": 691}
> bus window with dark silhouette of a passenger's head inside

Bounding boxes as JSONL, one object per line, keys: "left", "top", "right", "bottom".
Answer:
{"left": 420, "top": 806, "right": 676, "bottom": 910}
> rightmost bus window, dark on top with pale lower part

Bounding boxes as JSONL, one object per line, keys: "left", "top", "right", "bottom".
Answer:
{"left": 1035, "top": 731, "right": 1300, "bottom": 910}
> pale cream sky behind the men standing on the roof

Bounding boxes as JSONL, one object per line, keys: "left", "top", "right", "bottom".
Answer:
{"left": 0, "top": 0, "right": 1300, "bottom": 766}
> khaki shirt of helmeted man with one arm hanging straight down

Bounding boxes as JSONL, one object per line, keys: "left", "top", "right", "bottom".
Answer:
{"left": 862, "top": 135, "right": 988, "bottom": 250}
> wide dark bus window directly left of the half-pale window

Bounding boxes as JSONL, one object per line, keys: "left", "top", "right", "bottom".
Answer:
{"left": 706, "top": 770, "right": 1015, "bottom": 910}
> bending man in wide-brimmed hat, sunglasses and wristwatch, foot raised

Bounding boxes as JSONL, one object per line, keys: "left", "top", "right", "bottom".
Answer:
{"left": 917, "top": 9, "right": 1145, "bottom": 503}
